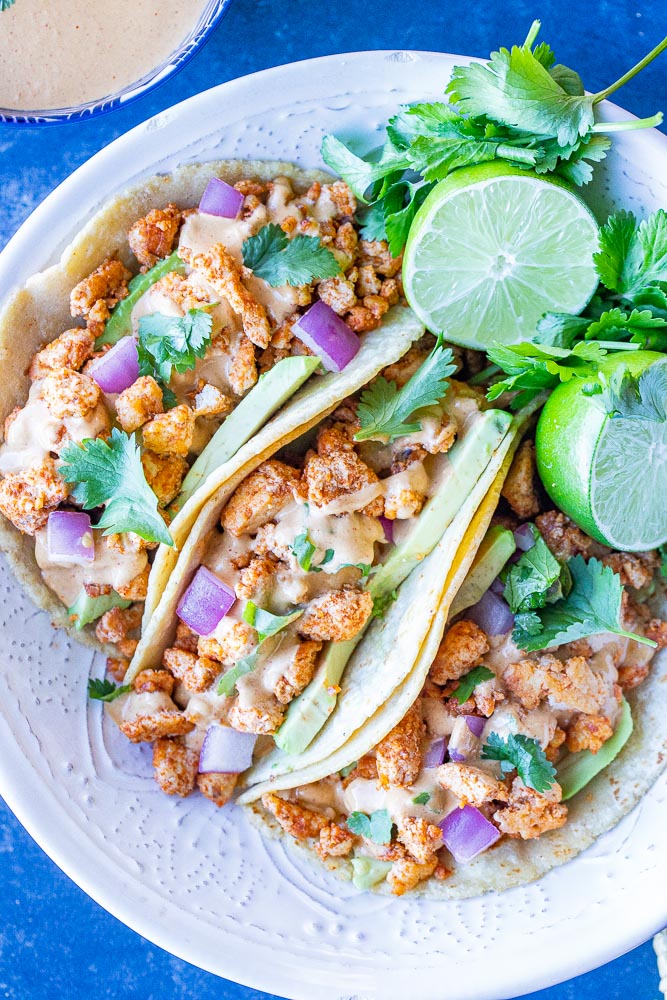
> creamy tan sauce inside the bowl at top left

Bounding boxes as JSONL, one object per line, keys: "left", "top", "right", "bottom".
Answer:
{"left": 0, "top": 0, "right": 206, "bottom": 111}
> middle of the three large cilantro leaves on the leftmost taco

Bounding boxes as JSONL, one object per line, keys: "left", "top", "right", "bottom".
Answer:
{"left": 137, "top": 309, "right": 213, "bottom": 392}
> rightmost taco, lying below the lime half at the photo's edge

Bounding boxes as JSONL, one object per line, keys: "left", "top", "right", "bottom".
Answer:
{"left": 240, "top": 442, "right": 667, "bottom": 899}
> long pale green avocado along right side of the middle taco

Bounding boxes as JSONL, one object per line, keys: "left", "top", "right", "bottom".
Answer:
{"left": 274, "top": 410, "right": 512, "bottom": 755}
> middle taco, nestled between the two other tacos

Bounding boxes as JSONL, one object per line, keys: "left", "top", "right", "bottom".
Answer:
{"left": 109, "top": 335, "right": 518, "bottom": 805}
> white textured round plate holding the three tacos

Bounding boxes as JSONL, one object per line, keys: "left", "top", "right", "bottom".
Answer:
{"left": 0, "top": 52, "right": 667, "bottom": 1000}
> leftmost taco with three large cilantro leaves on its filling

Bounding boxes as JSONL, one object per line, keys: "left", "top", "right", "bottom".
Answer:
{"left": 0, "top": 161, "right": 423, "bottom": 656}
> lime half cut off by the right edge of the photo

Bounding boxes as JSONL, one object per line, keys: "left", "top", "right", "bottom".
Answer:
{"left": 535, "top": 351, "right": 667, "bottom": 552}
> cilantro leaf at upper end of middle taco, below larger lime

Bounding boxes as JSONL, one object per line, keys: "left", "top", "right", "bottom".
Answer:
{"left": 354, "top": 338, "right": 456, "bottom": 441}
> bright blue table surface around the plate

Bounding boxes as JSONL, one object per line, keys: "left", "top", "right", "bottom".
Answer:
{"left": 0, "top": 0, "right": 667, "bottom": 1000}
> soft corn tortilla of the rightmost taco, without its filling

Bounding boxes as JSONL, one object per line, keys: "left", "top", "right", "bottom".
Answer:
{"left": 245, "top": 464, "right": 667, "bottom": 899}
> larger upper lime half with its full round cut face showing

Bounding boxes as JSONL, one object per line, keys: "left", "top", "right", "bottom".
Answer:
{"left": 403, "top": 163, "right": 598, "bottom": 350}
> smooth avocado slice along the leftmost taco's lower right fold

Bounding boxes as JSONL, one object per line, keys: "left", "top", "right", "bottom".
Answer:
{"left": 170, "top": 357, "right": 320, "bottom": 514}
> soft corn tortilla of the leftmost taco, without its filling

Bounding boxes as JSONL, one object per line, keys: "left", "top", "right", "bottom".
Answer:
{"left": 0, "top": 160, "right": 424, "bottom": 648}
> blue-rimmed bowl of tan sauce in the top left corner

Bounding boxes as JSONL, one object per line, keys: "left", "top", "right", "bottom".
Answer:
{"left": 0, "top": 0, "right": 231, "bottom": 125}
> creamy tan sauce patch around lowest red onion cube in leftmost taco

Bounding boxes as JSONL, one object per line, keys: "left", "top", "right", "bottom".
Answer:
{"left": 35, "top": 528, "right": 148, "bottom": 607}
